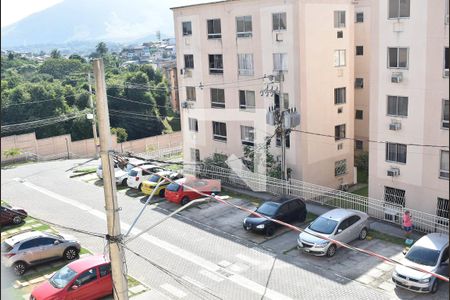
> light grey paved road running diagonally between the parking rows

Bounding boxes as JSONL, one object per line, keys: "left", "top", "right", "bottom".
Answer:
{"left": 1, "top": 160, "right": 442, "bottom": 300}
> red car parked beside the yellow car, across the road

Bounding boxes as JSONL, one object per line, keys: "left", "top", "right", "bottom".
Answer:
{"left": 164, "top": 178, "right": 220, "bottom": 205}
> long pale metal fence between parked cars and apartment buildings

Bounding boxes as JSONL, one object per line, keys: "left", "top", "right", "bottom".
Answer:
{"left": 184, "top": 165, "right": 449, "bottom": 234}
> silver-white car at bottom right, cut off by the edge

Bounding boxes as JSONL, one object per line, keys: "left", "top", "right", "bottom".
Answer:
{"left": 392, "top": 233, "right": 448, "bottom": 294}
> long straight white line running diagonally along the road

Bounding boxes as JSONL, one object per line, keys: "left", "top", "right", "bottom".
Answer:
{"left": 19, "top": 178, "right": 292, "bottom": 300}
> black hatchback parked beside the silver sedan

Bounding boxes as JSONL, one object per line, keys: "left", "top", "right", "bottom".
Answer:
{"left": 243, "top": 196, "right": 307, "bottom": 236}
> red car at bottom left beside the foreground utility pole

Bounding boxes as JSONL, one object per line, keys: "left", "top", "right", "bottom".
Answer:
{"left": 30, "top": 255, "right": 113, "bottom": 300}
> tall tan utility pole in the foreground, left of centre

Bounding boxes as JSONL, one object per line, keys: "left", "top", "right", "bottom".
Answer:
{"left": 92, "top": 58, "right": 128, "bottom": 300}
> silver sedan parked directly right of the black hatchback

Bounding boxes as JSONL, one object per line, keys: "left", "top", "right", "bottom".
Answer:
{"left": 297, "top": 208, "right": 369, "bottom": 257}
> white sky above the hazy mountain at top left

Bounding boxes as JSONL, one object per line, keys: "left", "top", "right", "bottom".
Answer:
{"left": 1, "top": 0, "right": 218, "bottom": 27}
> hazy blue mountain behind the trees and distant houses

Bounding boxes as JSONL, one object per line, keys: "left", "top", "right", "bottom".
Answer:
{"left": 1, "top": 0, "right": 183, "bottom": 49}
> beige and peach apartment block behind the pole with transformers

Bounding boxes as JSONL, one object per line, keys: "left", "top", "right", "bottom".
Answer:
{"left": 172, "top": 0, "right": 356, "bottom": 188}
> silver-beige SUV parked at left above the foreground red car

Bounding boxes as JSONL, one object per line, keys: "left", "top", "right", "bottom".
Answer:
{"left": 1, "top": 231, "right": 81, "bottom": 276}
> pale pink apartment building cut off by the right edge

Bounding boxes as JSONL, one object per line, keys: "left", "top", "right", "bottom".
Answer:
{"left": 369, "top": 0, "right": 449, "bottom": 220}
